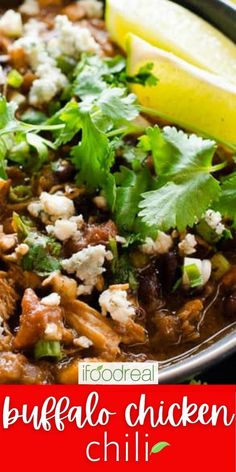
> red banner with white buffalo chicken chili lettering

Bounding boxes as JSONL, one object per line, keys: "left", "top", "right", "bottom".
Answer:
{"left": 0, "top": 385, "right": 236, "bottom": 472}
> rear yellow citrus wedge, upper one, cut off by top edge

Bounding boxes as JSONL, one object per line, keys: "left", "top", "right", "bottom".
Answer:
{"left": 106, "top": 0, "right": 236, "bottom": 83}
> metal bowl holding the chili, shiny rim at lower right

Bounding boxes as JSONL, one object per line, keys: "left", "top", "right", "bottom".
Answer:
{"left": 0, "top": 0, "right": 236, "bottom": 383}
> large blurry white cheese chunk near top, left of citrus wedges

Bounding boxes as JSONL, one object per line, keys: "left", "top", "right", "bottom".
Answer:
{"left": 48, "top": 15, "right": 99, "bottom": 59}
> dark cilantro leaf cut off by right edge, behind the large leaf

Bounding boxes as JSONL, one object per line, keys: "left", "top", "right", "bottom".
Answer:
{"left": 214, "top": 172, "right": 236, "bottom": 226}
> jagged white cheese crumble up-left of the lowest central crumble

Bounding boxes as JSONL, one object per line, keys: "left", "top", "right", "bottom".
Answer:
{"left": 62, "top": 244, "right": 113, "bottom": 295}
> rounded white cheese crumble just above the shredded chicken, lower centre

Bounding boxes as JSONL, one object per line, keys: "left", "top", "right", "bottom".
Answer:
{"left": 99, "top": 286, "right": 135, "bottom": 323}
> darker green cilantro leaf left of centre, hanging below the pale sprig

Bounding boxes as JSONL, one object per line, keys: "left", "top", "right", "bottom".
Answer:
{"left": 71, "top": 112, "right": 114, "bottom": 190}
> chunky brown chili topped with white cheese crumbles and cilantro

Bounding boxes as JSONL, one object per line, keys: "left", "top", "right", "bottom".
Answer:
{"left": 0, "top": 0, "right": 236, "bottom": 384}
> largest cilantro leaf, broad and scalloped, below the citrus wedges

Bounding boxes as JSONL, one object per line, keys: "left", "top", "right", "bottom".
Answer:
{"left": 139, "top": 127, "right": 221, "bottom": 231}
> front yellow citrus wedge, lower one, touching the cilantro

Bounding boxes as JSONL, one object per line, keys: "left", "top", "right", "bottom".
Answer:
{"left": 127, "top": 34, "right": 236, "bottom": 147}
